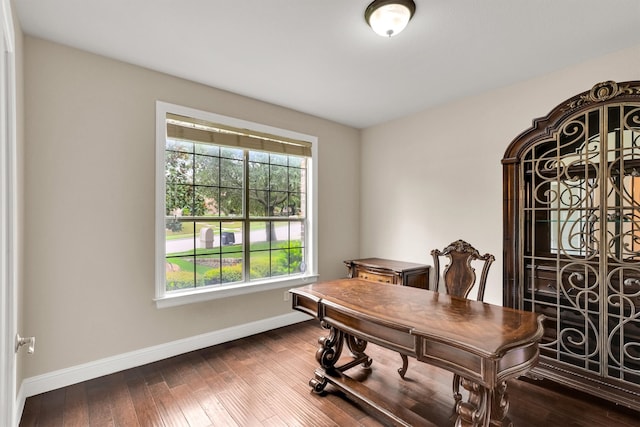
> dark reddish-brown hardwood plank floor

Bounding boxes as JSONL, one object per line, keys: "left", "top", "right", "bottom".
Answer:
{"left": 20, "top": 321, "right": 640, "bottom": 427}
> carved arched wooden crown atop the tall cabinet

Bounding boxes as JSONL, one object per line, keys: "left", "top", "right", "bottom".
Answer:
{"left": 502, "top": 80, "right": 640, "bottom": 164}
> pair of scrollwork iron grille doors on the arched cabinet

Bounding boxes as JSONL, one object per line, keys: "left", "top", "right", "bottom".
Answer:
{"left": 520, "top": 104, "right": 640, "bottom": 383}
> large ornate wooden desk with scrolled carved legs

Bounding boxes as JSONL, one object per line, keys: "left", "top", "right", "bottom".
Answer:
{"left": 290, "top": 279, "right": 543, "bottom": 426}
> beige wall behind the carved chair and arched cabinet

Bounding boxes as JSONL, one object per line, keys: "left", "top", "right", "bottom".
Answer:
{"left": 360, "top": 46, "right": 640, "bottom": 304}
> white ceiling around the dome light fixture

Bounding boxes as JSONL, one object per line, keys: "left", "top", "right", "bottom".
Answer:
{"left": 13, "top": 0, "right": 640, "bottom": 128}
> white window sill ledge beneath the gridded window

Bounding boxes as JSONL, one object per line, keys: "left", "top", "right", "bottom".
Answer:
{"left": 154, "top": 274, "right": 318, "bottom": 308}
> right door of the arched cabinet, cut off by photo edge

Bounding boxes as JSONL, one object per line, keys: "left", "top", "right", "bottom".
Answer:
{"left": 602, "top": 105, "right": 640, "bottom": 383}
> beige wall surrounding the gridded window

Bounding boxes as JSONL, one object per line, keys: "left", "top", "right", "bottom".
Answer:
{"left": 22, "top": 37, "right": 360, "bottom": 378}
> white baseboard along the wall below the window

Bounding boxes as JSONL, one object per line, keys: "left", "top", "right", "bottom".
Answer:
{"left": 16, "top": 312, "right": 310, "bottom": 420}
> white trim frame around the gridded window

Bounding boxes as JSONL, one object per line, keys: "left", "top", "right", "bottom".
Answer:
{"left": 154, "top": 101, "right": 318, "bottom": 308}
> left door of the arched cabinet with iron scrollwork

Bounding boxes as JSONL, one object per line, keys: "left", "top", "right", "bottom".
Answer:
{"left": 521, "top": 109, "right": 603, "bottom": 374}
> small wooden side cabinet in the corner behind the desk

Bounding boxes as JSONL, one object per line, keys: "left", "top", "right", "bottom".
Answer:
{"left": 344, "top": 258, "right": 430, "bottom": 289}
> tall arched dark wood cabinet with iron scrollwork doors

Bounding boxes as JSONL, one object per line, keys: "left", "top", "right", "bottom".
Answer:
{"left": 502, "top": 81, "right": 640, "bottom": 410}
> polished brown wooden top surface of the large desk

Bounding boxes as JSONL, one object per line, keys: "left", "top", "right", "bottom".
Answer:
{"left": 291, "top": 279, "right": 542, "bottom": 357}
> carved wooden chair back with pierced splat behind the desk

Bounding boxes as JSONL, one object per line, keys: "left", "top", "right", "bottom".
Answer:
{"left": 431, "top": 240, "right": 495, "bottom": 301}
